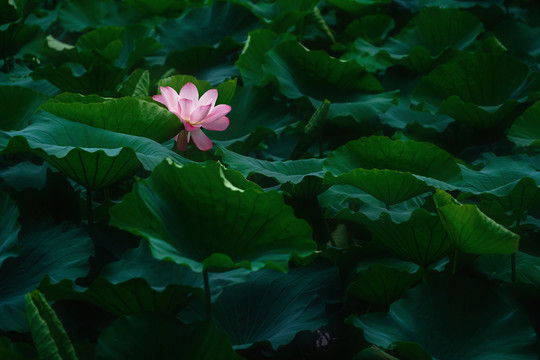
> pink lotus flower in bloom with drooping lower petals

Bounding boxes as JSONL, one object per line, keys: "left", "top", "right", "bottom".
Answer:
{"left": 152, "top": 83, "right": 231, "bottom": 151}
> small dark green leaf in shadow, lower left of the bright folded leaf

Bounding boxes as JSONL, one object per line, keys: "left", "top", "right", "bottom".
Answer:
{"left": 347, "top": 259, "right": 422, "bottom": 306}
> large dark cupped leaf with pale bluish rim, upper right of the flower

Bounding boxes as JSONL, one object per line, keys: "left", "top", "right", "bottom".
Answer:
{"left": 251, "top": 37, "right": 397, "bottom": 122}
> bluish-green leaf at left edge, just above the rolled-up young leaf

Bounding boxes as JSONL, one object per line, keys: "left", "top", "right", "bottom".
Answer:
{"left": 0, "top": 226, "right": 94, "bottom": 332}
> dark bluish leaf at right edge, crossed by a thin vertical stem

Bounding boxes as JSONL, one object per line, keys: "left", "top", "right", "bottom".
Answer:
{"left": 474, "top": 251, "right": 540, "bottom": 286}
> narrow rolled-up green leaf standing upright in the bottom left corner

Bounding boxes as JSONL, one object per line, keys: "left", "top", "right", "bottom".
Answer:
{"left": 25, "top": 290, "right": 77, "bottom": 360}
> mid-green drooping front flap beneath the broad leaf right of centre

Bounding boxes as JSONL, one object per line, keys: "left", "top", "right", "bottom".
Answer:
{"left": 324, "top": 169, "right": 432, "bottom": 205}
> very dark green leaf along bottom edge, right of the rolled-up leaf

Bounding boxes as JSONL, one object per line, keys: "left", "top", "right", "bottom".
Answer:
{"left": 96, "top": 313, "right": 241, "bottom": 360}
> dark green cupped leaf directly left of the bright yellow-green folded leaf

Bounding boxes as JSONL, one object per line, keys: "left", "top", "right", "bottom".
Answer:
{"left": 341, "top": 209, "right": 454, "bottom": 267}
